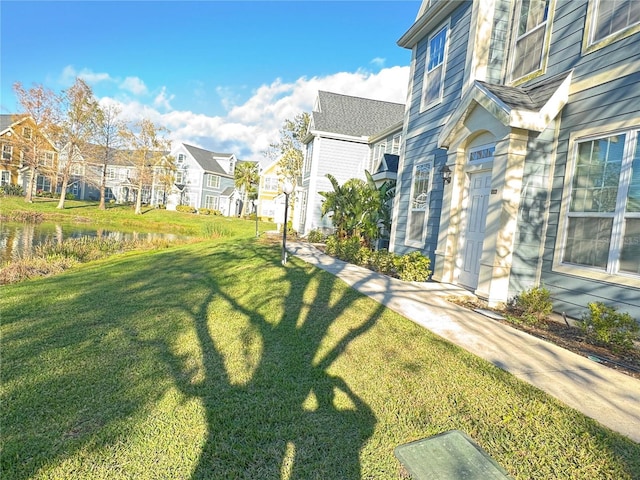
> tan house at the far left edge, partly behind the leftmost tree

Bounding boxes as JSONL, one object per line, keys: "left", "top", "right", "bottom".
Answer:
{"left": 0, "top": 114, "right": 58, "bottom": 193}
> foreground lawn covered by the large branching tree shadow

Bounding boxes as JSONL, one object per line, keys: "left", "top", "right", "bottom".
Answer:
{"left": 0, "top": 198, "right": 640, "bottom": 480}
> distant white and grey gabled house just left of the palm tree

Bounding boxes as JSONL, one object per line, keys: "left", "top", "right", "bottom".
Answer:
{"left": 167, "top": 143, "right": 242, "bottom": 216}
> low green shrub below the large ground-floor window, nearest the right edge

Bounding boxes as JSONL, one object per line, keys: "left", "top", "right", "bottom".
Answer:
{"left": 578, "top": 302, "right": 640, "bottom": 350}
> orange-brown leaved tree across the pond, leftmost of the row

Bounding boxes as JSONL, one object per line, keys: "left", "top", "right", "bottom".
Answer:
{"left": 12, "top": 82, "right": 59, "bottom": 203}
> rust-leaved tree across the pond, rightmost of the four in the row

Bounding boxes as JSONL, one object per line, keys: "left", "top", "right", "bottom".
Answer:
{"left": 123, "top": 118, "right": 171, "bottom": 215}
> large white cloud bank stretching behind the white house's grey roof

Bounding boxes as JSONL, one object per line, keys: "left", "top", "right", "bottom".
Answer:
{"left": 101, "top": 67, "right": 409, "bottom": 165}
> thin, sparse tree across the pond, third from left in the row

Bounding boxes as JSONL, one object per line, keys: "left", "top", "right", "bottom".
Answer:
{"left": 92, "top": 104, "right": 126, "bottom": 210}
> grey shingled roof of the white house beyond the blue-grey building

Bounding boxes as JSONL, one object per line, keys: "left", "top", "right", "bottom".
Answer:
{"left": 310, "top": 91, "right": 405, "bottom": 137}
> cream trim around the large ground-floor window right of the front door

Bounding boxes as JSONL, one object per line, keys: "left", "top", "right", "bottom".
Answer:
{"left": 552, "top": 125, "right": 640, "bottom": 288}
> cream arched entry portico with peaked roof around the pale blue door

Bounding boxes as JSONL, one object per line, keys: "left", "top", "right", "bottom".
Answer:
{"left": 433, "top": 72, "right": 571, "bottom": 305}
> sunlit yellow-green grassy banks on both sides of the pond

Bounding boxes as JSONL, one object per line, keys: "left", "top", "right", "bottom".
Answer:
{"left": 0, "top": 197, "right": 264, "bottom": 285}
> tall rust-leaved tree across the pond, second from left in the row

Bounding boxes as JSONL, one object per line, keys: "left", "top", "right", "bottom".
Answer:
{"left": 57, "top": 78, "right": 98, "bottom": 209}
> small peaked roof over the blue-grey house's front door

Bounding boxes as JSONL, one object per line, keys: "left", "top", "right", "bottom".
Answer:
{"left": 438, "top": 71, "right": 573, "bottom": 148}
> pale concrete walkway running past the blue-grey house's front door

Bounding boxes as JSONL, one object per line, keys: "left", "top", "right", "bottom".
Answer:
{"left": 287, "top": 242, "right": 640, "bottom": 443}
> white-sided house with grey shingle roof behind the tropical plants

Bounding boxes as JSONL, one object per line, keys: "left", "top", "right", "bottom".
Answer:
{"left": 293, "top": 91, "right": 405, "bottom": 234}
